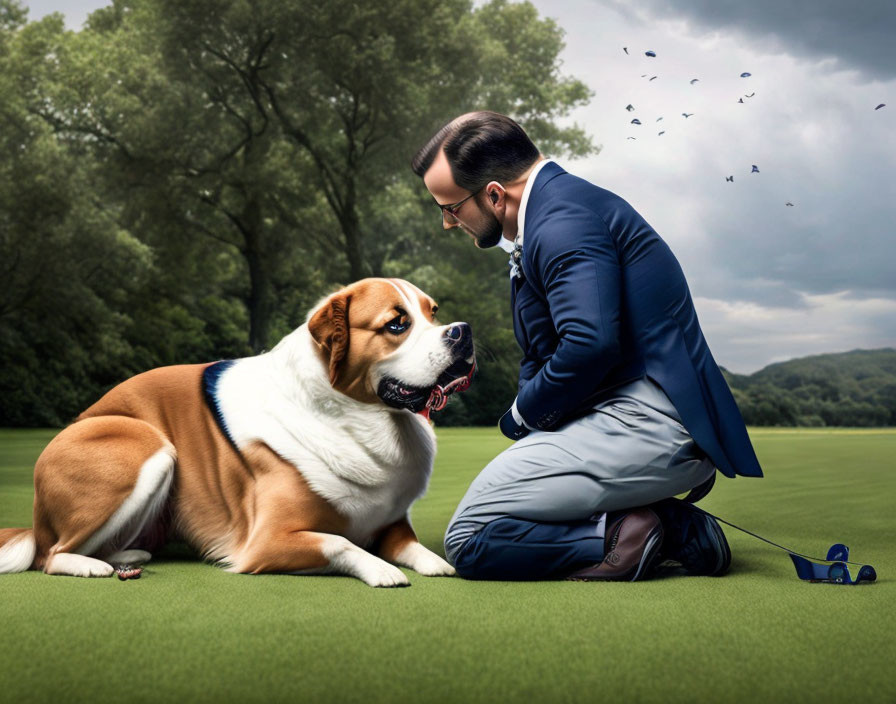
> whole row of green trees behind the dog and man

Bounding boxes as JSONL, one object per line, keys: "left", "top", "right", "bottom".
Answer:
{"left": 0, "top": 0, "right": 597, "bottom": 426}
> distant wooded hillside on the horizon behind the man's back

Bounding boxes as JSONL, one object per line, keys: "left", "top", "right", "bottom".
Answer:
{"left": 722, "top": 347, "right": 896, "bottom": 427}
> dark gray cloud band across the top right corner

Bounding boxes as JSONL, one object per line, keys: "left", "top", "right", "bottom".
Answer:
{"left": 613, "top": 0, "right": 896, "bottom": 81}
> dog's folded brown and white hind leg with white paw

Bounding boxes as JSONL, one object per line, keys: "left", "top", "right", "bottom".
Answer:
{"left": 34, "top": 416, "right": 176, "bottom": 577}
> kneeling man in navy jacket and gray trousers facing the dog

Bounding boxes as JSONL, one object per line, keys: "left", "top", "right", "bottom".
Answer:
{"left": 412, "top": 112, "right": 762, "bottom": 581}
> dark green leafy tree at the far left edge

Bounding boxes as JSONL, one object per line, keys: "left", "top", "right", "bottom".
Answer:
{"left": 0, "top": 6, "right": 152, "bottom": 425}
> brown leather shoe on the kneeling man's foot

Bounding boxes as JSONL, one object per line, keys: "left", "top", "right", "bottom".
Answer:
{"left": 567, "top": 508, "right": 663, "bottom": 582}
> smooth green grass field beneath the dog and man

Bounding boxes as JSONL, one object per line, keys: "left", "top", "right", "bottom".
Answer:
{"left": 0, "top": 428, "right": 896, "bottom": 704}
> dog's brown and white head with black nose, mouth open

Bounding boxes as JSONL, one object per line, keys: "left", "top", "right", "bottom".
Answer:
{"left": 308, "top": 279, "right": 475, "bottom": 412}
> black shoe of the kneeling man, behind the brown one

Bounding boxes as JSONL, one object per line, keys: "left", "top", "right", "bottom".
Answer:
{"left": 651, "top": 498, "right": 731, "bottom": 577}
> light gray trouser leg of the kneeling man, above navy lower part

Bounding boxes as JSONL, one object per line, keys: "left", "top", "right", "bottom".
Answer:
{"left": 445, "top": 377, "right": 715, "bottom": 564}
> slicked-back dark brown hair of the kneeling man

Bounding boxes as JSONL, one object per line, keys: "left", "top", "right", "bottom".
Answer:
{"left": 411, "top": 110, "right": 539, "bottom": 191}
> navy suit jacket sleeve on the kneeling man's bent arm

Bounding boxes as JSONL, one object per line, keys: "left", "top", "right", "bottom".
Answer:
{"left": 517, "top": 208, "right": 621, "bottom": 430}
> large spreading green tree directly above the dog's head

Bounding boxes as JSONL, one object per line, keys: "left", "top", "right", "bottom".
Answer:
{"left": 35, "top": 0, "right": 593, "bottom": 350}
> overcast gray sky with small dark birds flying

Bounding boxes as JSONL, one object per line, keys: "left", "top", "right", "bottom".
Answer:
{"left": 26, "top": 0, "right": 896, "bottom": 373}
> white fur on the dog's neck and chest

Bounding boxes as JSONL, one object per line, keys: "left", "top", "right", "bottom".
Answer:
{"left": 217, "top": 325, "right": 435, "bottom": 545}
